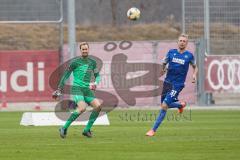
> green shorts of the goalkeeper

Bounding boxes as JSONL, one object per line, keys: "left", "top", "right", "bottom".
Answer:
{"left": 72, "top": 88, "right": 96, "bottom": 104}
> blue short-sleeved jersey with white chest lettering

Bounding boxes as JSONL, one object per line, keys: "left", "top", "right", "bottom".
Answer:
{"left": 164, "top": 49, "right": 196, "bottom": 85}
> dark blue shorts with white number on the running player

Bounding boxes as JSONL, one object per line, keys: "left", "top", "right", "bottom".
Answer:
{"left": 161, "top": 82, "right": 184, "bottom": 106}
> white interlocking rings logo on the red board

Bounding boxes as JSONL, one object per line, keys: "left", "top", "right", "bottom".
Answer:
{"left": 207, "top": 59, "right": 240, "bottom": 90}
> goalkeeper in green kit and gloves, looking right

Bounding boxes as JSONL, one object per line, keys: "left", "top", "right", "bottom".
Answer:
{"left": 52, "top": 42, "right": 101, "bottom": 138}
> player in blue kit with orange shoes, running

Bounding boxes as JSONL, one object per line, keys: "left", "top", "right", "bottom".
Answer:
{"left": 146, "top": 34, "right": 198, "bottom": 137}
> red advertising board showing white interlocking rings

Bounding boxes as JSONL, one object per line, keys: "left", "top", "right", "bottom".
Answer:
{"left": 205, "top": 56, "right": 240, "bottom": 92}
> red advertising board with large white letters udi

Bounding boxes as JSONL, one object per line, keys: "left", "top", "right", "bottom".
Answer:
{"left": 0, "top": 51, "right": 59, "bottom": 102}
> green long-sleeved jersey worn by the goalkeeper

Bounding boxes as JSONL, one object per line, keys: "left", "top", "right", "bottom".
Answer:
{"left": 58, "top": 57, "right": 100, "bottom": 88}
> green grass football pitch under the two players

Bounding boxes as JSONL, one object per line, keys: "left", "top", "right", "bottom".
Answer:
{"left": 0, "top": 110, "right": 240, "bottom": 160}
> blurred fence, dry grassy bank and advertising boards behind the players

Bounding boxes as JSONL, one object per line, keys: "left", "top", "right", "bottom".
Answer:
{"left": 0, "top": 0, "right": 240, "bottom": 110}
